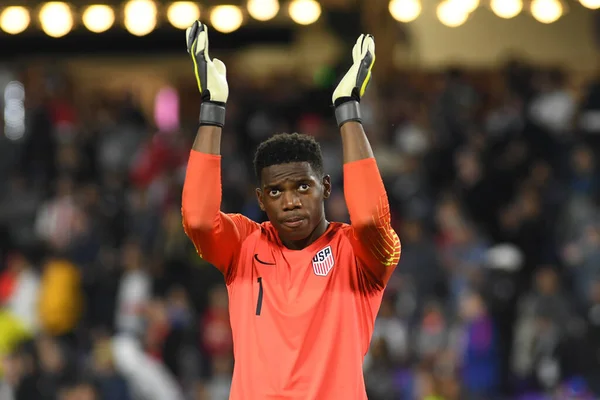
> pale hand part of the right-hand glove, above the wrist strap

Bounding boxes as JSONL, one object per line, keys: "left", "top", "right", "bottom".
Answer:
{"left": 332, "top": 34, "right": 375, "bottom": 106}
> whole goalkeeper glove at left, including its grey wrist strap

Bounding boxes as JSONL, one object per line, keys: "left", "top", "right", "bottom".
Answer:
{"left": 186, "top": 21, "right": 229, "bottom": 127}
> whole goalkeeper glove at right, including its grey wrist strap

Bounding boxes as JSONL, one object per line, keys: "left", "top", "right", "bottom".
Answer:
{"left": 332, "top": 34, "right": 375, "bottom": 126}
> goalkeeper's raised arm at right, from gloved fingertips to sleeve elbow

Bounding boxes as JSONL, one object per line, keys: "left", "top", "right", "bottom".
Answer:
{"left": 333, "top": 35, "right": 400, "bottom": 289}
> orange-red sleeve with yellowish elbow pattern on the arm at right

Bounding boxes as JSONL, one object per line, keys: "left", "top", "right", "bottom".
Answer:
{"left": 344, "top": 158, "right": 400, "bottom": 289}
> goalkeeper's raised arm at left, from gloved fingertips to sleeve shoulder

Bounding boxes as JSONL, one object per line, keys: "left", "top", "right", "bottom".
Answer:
{"left": 181, "top": 22, "right": 258, "bottom": 283}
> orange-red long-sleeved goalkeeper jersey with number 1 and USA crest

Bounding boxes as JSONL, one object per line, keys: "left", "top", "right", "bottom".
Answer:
{"left": 182, "top": 150, "right": 400, "bottom": 400}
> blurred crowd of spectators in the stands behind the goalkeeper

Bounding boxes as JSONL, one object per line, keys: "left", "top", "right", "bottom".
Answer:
{"left": 0, "top": 58, "right": 600, "bottom": 400}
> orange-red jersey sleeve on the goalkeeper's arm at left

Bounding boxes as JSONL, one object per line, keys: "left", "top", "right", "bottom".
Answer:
{"left": 181, "top": 150, "right": 259, "bottom": 283}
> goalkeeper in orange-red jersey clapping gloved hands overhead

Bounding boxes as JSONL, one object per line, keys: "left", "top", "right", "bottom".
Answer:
{"left": 182, "top": 22, "right": 400, "bottom": 400}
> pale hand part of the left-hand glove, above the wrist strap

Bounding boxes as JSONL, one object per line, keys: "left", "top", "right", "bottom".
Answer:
{"left": 186, "top": 21, "right": 229, "bottom": 103}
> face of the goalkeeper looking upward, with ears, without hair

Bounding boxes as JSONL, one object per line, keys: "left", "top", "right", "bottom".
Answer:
{"left": 256, "top": 162, "right": 331, "bottom": 241}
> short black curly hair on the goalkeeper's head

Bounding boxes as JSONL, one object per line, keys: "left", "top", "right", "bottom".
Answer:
{"left": 254, "top": 133, "right": 323, "bottom": 182}
